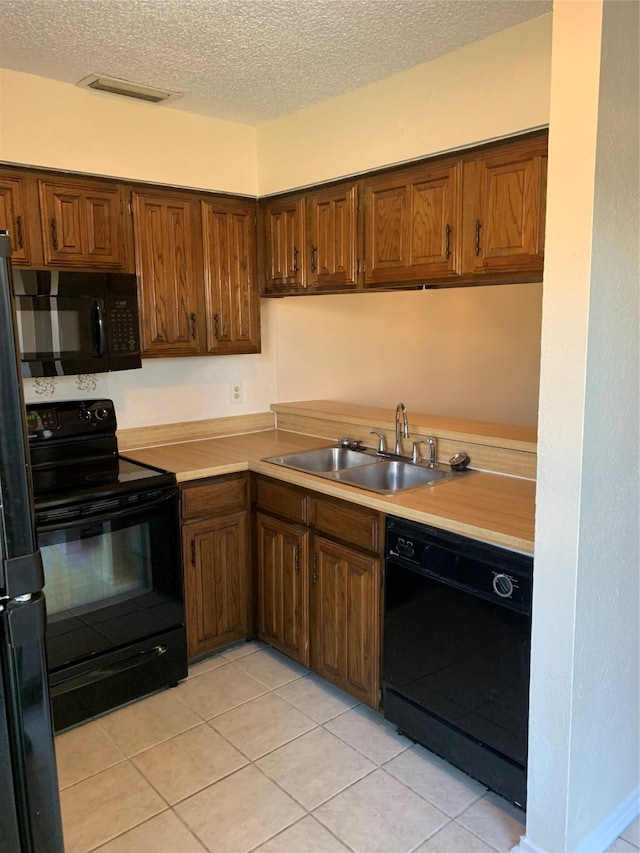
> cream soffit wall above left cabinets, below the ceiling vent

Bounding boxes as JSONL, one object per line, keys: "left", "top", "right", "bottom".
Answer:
{"left": 0, "top": 68, "right": 258, "bottom": 195}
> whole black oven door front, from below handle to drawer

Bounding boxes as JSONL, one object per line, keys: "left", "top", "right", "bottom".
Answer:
{"left": 38, "top": 492, "right": 184, "bottom": 672}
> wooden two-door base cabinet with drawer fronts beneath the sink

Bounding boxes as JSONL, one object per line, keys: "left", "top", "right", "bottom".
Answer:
{"left": 254, "top": 476, "right": 383, "bottom": 709}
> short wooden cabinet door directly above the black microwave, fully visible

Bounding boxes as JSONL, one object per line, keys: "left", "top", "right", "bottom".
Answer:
{"left": 38, "top": 181, "right": 125, "bottom": 270}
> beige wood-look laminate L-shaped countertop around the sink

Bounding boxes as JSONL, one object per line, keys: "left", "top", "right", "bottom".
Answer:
{"left": 123, "top": 430, "right": 535, "bottom": 554}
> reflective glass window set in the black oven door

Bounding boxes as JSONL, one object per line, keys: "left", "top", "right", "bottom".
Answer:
{"left": 40, "top": 522, "right": 152, "bottom": 617}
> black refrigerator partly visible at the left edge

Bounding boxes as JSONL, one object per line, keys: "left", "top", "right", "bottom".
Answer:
{"left": 0, "top": 231, "right": 64, "bottom": 853}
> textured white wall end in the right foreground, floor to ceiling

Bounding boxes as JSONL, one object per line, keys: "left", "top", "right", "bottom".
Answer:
{"left": 522, "top": 0, "right": 640, "bottom": 853}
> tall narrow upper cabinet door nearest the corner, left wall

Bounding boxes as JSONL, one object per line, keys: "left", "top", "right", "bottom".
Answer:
{"left": 201, "top": 199, "right": 260, "bottom": 354}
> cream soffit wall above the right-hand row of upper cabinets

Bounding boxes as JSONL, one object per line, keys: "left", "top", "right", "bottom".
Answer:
{"left": 258, "top": 14, "right": 551, "bottom": 195}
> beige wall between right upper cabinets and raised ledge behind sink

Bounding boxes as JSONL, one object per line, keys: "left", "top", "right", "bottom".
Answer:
{"left": 277, "top": 284, "right": 542, "bottom": 426}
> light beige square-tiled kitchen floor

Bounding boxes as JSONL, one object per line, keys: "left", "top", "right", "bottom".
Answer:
{"left": 56, "top": 643, "right": 640, "bottom": 853}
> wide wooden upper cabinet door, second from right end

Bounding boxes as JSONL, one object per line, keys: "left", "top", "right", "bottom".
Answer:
{"left": 365, "top": 160, "right": 462, "bottom": 285}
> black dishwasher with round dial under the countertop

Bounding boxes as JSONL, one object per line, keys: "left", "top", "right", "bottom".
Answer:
{"left": 383, "top": 517, "right": 533, "bottom": 809}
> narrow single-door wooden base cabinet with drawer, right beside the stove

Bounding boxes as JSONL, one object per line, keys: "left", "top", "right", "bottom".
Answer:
{"left": 181, "top": 474, "right": 251, "bottom": 658}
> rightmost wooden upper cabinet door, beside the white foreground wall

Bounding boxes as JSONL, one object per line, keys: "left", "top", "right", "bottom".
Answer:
{"left": 473, "top": 137, "right": 547, "bottom": 274}
